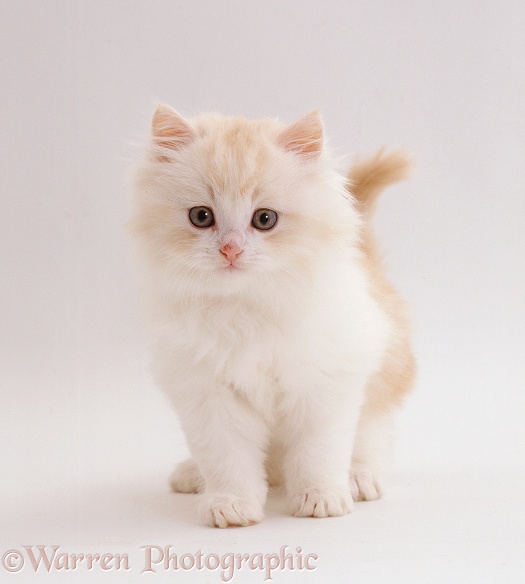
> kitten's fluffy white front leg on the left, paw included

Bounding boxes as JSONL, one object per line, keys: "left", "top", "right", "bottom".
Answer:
{"left": 178, "top": 387, "right": 268, "bottom": 527}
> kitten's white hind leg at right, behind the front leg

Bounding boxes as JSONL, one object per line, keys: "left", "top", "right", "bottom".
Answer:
{"left": 350, "top": 410, "right": 393, "bottom": 501}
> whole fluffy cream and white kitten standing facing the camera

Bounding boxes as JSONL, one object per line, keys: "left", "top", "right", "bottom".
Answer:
{"left": 131, "top": 105, "right": 414, "bottom": 527}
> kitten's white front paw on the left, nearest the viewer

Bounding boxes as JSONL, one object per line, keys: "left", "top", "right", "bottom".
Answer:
{"left": 200, "top": 495, "right": 264, "bottom": 528}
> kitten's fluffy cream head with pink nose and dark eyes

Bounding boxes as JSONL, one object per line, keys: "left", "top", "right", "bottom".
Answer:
{"left": 132, "top": 106, "right": 358, "bottom": 293}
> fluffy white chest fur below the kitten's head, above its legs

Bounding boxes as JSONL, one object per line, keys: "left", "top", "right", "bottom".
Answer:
{"left": 149, "top": 258, "right": 389, "bottom": 418}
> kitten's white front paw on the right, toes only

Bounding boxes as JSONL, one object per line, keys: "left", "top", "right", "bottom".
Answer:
{"left": 291, "top": 487, "right": 353, "bottom": 517}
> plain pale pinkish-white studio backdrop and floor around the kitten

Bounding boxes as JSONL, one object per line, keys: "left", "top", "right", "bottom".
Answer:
{"left": 0, "top": 0, "right": 525, "bottom": 583}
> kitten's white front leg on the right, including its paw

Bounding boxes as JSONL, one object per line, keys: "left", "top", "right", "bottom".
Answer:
{"left": 284, "top": 376, "right": 363, "bottom": 517}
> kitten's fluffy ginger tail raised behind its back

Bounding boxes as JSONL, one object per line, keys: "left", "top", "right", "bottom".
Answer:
{"left": 348, "top": 150, "right": 413, "bottom": 215}
